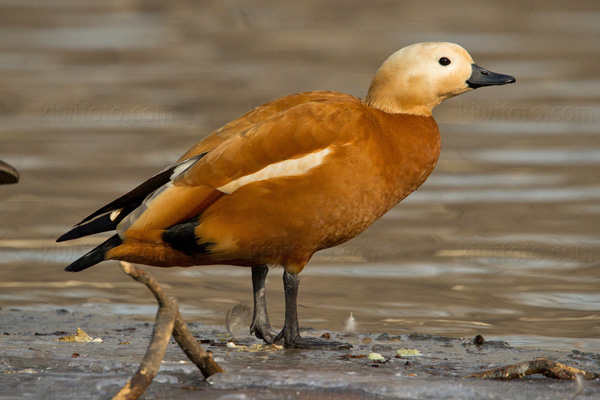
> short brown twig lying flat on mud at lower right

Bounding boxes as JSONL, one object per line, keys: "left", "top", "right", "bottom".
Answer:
{"left": 465, "top": 358, "right": 600, "bottom": 380}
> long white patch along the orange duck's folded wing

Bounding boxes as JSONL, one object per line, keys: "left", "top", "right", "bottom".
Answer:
{"left": 217, "top": 148, "right": 330, "bottom": 194}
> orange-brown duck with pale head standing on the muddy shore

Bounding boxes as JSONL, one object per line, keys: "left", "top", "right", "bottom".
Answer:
{"left": 57, "top": 42, "right": 515, "bottom": 349}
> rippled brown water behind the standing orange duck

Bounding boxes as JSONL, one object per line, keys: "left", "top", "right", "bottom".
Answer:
{"left": 0, "top": 1, "right": 600, "bottom": 350}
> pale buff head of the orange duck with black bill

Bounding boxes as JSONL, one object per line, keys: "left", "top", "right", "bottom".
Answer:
{"left": 364, "top": 42, "right": 515, "bottom": 116}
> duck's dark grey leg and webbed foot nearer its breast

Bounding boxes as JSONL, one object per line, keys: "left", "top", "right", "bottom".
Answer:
{"left": 275, "top": 272, "right": 352, "bottom": 349}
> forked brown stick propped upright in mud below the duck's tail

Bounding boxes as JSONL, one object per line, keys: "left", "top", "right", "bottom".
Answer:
{"left": 113, "top": 261, "right": 225, "bottom": 400}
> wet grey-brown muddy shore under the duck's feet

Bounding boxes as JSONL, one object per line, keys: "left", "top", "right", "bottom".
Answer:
{"left": 0, "top": 308, "right": 600, "bottom": 400}
